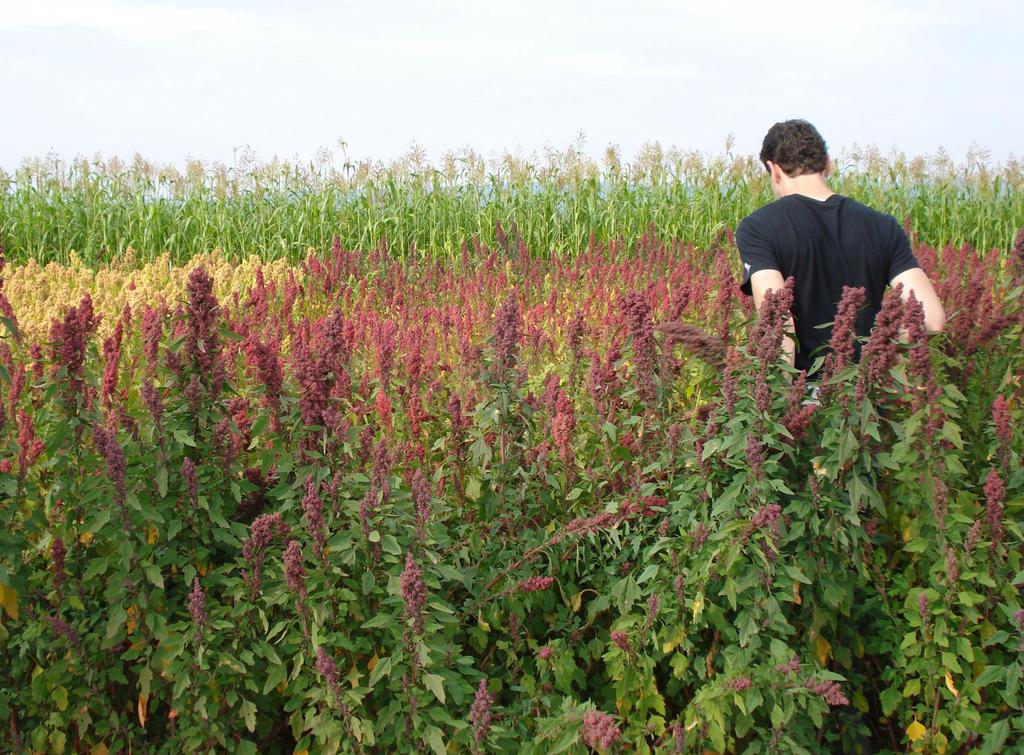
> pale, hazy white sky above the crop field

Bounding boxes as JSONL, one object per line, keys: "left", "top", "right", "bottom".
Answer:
{"left": 0, "top": 0, "right": 1024, "bottom": 170}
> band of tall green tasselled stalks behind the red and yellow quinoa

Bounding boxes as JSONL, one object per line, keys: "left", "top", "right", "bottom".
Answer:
{"left": 0, "top": 144, "right": 1024, "bottom": 265}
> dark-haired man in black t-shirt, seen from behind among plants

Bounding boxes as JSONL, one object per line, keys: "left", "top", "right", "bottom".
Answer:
{"left": 736, "top": 120, "right": 945, "bottom": 370}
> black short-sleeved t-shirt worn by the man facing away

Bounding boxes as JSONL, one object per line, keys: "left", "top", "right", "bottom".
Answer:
{"left": 736, "top": 194, "right": 919, "bottom": 370}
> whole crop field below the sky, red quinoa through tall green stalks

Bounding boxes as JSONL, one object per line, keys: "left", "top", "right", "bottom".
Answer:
{"left": 0, "top": 146, "right": 1024, "bottom": 755}
